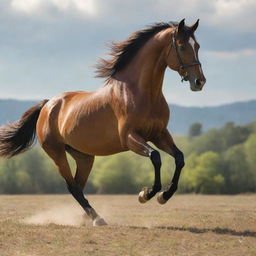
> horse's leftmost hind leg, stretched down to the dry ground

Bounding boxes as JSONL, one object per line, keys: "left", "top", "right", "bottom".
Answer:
{"left": 43, "top": 144, "right": 105, "bottom": 225}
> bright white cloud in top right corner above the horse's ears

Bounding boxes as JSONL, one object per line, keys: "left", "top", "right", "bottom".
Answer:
{"left": 151, "top": 0, "right": 256, "bottom": 31}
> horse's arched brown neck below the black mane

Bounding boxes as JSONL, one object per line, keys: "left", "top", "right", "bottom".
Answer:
{"left": 115, "top": 39, "right": 166, "bottom": 103}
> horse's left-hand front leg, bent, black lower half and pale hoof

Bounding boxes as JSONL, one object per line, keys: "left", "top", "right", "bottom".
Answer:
{"left": 126, "top": 132, "right": 162, "bottom": 203}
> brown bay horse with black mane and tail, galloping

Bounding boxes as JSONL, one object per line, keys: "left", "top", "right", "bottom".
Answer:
{"left": 0, "top": 20, "right": 205, "bottom": 225}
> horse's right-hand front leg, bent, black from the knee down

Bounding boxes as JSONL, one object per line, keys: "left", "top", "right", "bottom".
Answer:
{"left": 152, "top": 130, "right": 185, "bottom": 204}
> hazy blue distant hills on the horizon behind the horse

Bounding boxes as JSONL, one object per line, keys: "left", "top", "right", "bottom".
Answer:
{"left": 0, "top": 99, "right": 256, "bottom": 134}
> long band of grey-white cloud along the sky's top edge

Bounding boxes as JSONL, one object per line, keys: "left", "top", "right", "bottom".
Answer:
{"left": 9, "top": 0, "right": 256, "bottom": 31}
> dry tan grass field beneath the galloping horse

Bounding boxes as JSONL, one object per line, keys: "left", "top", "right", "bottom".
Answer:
{"left": 0, "top": 195, "right": 256, "bottom": 256}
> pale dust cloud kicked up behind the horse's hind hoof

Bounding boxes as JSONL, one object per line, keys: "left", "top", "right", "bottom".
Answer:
{"left": 22, "top": 204, "right": 92, "bottom": 227}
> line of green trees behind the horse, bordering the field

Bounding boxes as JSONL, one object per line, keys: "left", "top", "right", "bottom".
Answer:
{"left": 0, "top": 122, "right": 256, "bottom": 194}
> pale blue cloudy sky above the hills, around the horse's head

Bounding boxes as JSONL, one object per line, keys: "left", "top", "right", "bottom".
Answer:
{"left": 0, "top": 0, "right": 256, "bottom": 106}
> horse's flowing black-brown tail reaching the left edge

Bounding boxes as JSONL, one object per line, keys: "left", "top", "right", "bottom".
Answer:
{"left": 0, "top": 100, "right": 48, "bottom": 157}
